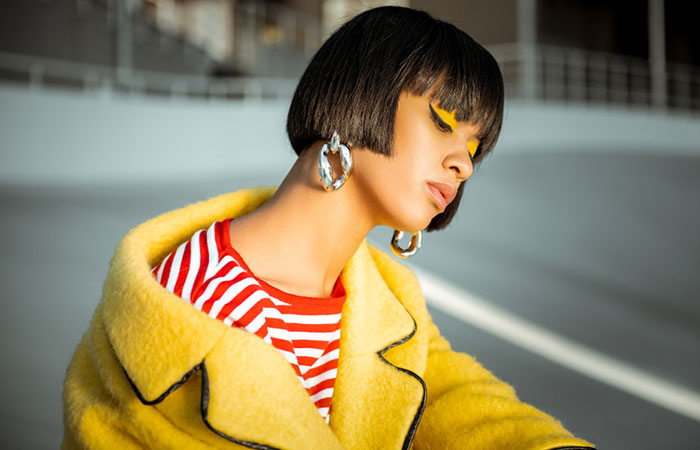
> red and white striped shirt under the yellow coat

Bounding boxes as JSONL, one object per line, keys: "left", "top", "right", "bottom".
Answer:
{"left": 153, "top": 219, "right": 345, "bottom": 422}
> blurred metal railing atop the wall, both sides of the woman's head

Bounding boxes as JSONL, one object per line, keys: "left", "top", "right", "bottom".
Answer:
{"left": 0, "top": 40, "right": 700, "bottom": 114}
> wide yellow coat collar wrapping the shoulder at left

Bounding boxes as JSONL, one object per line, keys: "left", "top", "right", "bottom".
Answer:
{"left": 103, "top": 188, "right": 274, "bottom": 401}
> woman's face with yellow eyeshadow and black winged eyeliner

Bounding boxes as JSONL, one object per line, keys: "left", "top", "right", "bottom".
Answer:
{"left": 353, "top": 93, "right": 479, "bottom": 232}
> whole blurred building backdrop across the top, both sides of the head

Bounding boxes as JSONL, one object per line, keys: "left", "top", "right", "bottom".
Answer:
{"left": 0, "top": 0, "right": 700, "bottom": 111}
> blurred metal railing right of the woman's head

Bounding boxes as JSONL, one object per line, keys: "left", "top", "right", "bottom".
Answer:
{"left": 488, "top": 44, "right": 700, "bottom": 113}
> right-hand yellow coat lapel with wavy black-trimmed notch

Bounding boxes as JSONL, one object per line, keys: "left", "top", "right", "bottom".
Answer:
{"left": 330, "top": 242, "right": 425, "bottom": 449}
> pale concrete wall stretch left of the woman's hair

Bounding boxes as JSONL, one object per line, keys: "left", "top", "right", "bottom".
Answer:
{"left": 0, "top": 85, "right": 296, "bottom": 184}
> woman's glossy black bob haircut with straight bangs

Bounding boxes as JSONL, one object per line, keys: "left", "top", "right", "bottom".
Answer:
{"left": 287, "top": 6, "right": 504, "bottom": 231}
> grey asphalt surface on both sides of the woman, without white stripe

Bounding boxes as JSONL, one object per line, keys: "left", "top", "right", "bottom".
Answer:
{"left": 0, "top": 152, "right": 700, "bottom": 450}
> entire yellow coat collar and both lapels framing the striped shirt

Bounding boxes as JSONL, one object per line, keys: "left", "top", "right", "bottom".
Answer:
{"left": 101, "top": 189, "right": 425, "bottom": 450}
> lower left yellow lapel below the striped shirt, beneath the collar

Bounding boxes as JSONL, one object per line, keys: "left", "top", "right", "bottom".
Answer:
{"left": 202, "top": 328, "right": 342, "bottom": 450}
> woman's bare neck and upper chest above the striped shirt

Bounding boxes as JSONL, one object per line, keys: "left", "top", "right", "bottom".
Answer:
{"left": 231, "top": 144, "right": 377, "bottom": 297}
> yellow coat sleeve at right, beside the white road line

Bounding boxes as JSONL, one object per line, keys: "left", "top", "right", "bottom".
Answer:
{"left": 414, "top": 318, "right": 593, "bottom": 450}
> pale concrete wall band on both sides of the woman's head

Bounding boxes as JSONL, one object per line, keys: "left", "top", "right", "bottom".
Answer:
{"left": 0, "top": 85, "right": 700, "bottom": 185}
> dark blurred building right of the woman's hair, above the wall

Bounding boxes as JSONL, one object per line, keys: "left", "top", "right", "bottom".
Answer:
{"left": 411, "top": 0, "right": 700, "bottom": 111}
